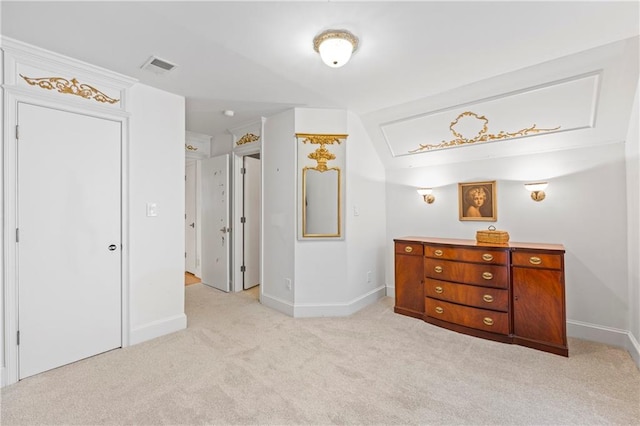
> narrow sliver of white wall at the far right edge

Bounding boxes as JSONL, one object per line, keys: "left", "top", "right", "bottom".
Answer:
{"left": 626, "top": 80, "right": 640, "bottom": 366}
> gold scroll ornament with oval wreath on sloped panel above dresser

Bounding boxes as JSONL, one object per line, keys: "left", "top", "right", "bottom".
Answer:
{"left": 409, "top": 111, "right": 560, "bottom": 154}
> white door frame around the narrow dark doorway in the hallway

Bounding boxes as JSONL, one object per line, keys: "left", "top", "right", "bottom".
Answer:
{"left": 231, "top": 143, "right": 264, "bottom": 299}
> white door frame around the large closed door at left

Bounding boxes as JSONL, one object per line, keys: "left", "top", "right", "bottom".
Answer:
{"left": 0, "top": 86, "right": 130, "bottom": 386}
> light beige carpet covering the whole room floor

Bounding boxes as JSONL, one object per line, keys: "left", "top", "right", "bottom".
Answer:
{"left": 1, "top": 284, "right": 640, "bottom": 426}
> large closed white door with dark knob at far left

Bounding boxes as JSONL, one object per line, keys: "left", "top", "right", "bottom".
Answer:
{"left": 17, "top": 103, "right": 122, "bottom": 379}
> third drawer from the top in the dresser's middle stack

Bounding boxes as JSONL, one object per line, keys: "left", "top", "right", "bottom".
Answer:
{"left": 424, "top": 278, "right": 509, "bottom": 312}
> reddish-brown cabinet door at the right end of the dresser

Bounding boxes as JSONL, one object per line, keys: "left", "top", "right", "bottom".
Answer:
{"left": 513, "top": 266, "right": 567, "bottom": 346}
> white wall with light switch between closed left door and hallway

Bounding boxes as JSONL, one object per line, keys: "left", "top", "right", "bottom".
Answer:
{"left": 128, "top": 84, "right": 186, "bottom": 344}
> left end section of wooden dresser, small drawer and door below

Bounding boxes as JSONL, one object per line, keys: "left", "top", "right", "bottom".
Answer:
{"left": 394, "top": 242, "right": 424, "bottom": 318}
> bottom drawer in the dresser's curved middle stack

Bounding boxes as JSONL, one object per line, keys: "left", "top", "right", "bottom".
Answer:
{"left": 425, "top": 297, "right": 509, "bottom": 335}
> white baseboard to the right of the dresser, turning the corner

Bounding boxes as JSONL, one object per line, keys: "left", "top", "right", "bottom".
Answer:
{"left": 567, "top": 320, "right": 640, "bottom": 368}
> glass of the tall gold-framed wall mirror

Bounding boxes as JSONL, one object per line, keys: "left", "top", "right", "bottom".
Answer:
{"left": 302, "top": 167, "right": 340, "bottom": 237}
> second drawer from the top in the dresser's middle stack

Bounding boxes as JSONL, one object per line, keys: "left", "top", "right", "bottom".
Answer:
{"left": 424, "top": 257, "right": 509, "bottom": 288}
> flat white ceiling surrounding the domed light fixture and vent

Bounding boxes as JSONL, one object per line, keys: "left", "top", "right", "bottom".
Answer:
{"left": 0, "top": 0, "right": 639, "bottom": 147}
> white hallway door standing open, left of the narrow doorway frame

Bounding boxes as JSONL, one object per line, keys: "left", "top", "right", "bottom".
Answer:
{"left": 200, "top": 154, "right": 231, "bottom": 292}
